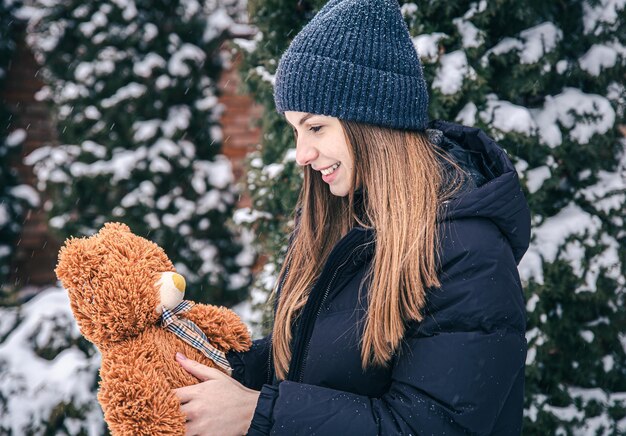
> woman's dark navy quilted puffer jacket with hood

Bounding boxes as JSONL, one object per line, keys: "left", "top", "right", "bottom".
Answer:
{"left": 228, "top": 121, "right": 530, "bottom": 436}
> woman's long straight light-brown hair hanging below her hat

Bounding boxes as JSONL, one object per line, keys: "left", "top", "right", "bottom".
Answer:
{"left": 272, "top": 120, "right": 463, "bottom": 379}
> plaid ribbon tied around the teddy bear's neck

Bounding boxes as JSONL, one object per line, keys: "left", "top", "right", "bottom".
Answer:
{"left": 161, "top": 300, "right": 232, "bottom": 375}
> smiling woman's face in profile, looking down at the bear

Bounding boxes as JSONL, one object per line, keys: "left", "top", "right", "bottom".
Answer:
{"left": 285, "top": 111, "right": 354, "bottom": 197}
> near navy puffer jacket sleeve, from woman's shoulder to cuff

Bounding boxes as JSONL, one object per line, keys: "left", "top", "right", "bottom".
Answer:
{"left": 249, "top": 217, "right": 526, "bottom": 435}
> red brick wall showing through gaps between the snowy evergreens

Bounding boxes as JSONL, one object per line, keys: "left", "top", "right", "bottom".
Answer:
{"left": 0, "top": 36, "right": 261, "bottom": 288}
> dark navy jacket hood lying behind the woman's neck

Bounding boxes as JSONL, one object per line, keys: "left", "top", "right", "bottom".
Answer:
{"left": 429, "top": 120, "right": 530, "bottom": 264}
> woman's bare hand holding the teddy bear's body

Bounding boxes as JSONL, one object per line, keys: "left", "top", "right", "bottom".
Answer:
{"left": 174, "top": 353, "right": 259, "bottom": 436}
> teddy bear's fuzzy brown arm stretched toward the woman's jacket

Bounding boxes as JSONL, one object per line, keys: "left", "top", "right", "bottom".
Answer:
{"left": 183, "top": 304, "right": 252, "bottom": 352}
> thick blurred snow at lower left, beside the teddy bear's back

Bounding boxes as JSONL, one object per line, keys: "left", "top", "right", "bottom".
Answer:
{"left": 0, "top": 287, "right": 103, "bottom": 434}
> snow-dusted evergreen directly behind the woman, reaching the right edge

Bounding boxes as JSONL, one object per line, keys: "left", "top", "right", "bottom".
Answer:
{"left": 235, "top": 0, "right": 626, "bottom": 435}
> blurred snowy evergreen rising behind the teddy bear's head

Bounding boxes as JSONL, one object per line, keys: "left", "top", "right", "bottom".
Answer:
{"left": 26, "top": 0, "right": 250, "bottom": 304}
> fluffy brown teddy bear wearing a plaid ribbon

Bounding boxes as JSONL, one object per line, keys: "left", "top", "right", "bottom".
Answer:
{"left": 55, "top": 223, "right": 251, "bottom": 435}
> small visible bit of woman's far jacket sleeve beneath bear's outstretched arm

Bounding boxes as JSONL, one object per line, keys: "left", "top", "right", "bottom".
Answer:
{"left": 226, "top": 336, "right": 271, "bottom": 391}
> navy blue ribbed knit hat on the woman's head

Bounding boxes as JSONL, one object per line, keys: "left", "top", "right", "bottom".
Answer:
{"left": 274, "top": 0, "right": 428, "bottom": 130}
